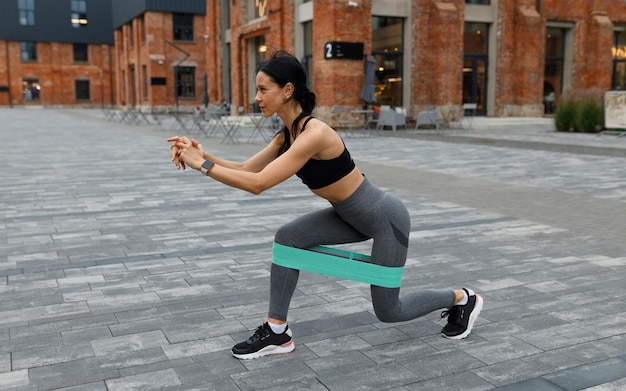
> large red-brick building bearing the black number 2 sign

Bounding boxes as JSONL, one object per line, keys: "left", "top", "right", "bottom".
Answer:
{"left": 218, "top": 0, "right": 626, "bottom": 116}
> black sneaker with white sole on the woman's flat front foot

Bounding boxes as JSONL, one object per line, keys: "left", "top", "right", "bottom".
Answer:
{"left": 231, "top": 322, "right": 296, "bottom": 360}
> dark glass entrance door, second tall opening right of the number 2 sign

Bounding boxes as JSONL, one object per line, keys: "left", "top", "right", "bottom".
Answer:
{"left": 463, "top": 55, "right": 488, "bottom": 115}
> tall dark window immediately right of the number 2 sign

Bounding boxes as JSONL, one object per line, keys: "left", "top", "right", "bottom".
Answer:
{"left": 372, "top": 16, "right": 404, "bottom": 107}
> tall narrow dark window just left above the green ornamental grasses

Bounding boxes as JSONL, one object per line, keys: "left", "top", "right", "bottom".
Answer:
{"left": 543, "top": 27, "right": 566, "bottom": 113}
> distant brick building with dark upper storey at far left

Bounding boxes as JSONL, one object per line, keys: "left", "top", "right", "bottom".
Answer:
{"left": 0, "top": 0, "right": 114, "bottom": 106}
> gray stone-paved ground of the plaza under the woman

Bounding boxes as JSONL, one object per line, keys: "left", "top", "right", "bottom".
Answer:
{"left": 0, "top": 108, "right": 626, "bottom": 391}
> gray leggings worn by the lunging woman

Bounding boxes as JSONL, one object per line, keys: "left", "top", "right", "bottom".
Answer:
{"left": 269, "top": 179, "right": 455, "bottom": 323}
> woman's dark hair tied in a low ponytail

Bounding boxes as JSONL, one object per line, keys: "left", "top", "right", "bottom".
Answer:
{"left": 256, "top": 50, "right": 315, "bottom": 153}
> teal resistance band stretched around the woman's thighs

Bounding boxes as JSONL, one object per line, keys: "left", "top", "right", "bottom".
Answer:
{"left": 272, "top": 243, "right": 404, "bottom": 288}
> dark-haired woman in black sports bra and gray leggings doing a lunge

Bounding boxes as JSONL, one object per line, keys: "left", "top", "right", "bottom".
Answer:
{"left": 168, "top": 51, "right": 483, "bottom": 359}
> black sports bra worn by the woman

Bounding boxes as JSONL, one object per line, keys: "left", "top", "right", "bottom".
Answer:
{"left": 296, "top": 117, "right": 356, "bottom": 189}
